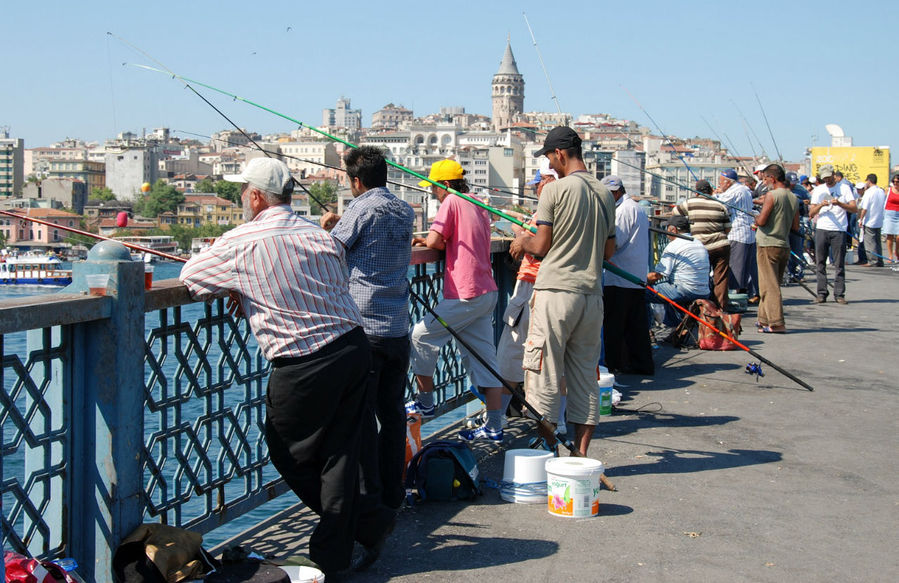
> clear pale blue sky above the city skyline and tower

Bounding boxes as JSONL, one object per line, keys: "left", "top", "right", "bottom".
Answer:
{"left": 0, "top": 0, "right": 899, "bottom": 161}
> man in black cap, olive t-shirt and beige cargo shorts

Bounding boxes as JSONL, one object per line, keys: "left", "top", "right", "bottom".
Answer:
{"left": 510, "top": 126, "right": 615, "bottom": 455}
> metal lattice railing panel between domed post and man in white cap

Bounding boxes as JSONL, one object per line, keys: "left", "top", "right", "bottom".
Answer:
{"left": 143, "top": 300, "right": 279, "bottom": 532}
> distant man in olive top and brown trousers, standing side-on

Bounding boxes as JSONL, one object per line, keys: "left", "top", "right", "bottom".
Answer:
{"left": 755, "top": 164, "right": 799, "bottom": 333}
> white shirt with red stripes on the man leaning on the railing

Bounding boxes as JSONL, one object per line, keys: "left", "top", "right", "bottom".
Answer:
{"left": 181, "top": 205, "right": 362, "bottom": 360}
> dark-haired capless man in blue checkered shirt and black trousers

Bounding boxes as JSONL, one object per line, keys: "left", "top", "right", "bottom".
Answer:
{"left": 321, "top": 146, "right": 415, "bottom": 570}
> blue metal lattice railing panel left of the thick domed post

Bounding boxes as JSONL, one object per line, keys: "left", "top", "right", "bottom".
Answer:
{"left": 0, "top": 328, "right": 69, "bottom": 556}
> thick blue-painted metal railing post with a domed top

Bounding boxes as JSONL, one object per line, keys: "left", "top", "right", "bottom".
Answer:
{"left": 69, "top": 241, "right": 144, "bottom": 583}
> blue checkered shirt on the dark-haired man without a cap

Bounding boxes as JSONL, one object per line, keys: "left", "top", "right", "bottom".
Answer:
{"left": 331, "top": 188, "right": 415, "bottom": 338}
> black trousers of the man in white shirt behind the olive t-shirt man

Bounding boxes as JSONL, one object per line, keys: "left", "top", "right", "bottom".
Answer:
{"left": 602, "top": 285, "right": 655, "bottom": 375}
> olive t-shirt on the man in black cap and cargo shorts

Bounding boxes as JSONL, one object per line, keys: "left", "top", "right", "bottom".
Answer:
{"left": 534, "top": 171, "right": 615, "bottom": 294}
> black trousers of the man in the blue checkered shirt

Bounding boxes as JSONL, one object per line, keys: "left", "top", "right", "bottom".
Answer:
{"left": 359, "top": 335, "right": 410, "bottom": 524}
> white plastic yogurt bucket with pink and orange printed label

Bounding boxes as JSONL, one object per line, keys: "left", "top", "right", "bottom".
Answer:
{"left": 546, "top": 457, "right": 603, "bottom": 518}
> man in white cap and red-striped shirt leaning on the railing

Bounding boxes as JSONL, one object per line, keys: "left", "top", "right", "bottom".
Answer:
{"left": 181, "top": 158, "right": 374, "bottom": 580}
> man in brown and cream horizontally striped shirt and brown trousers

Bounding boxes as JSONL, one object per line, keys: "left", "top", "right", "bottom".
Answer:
{"left": 672, "top": 180, "right": 730, "bottom": 310}
